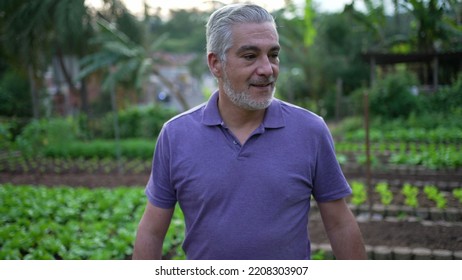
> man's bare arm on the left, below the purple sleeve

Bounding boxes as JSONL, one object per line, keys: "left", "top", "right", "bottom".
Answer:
{"left": 132, "top": 202, "right": 175, "bottom": 260}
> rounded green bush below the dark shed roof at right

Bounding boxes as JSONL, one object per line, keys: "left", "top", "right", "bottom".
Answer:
{"left": 370, "top": 71, "right": 421, "bottom": 119}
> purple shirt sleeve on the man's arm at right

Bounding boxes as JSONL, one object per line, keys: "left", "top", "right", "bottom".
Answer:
{"left": 312, "top": 121, "right": 352, "bottom": 202}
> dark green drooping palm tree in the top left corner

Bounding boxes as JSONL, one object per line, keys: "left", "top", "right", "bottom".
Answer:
{"left": 0, "top": 0, "right": 91, "bottom": 118}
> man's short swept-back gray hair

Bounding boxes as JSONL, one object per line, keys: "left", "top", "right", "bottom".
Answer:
{"left": 206, "top": 4, "right": 276, "bottom": 62}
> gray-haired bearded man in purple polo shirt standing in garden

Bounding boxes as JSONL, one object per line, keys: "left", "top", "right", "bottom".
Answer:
{"left": 133, "top": 4, "right": 366, "bottom": 259}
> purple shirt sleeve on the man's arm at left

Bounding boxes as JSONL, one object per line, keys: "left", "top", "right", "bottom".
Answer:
{"left": 145, "top": 126, "right": 177, "bottom": 209}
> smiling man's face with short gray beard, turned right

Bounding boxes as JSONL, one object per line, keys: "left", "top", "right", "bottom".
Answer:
{"left": 221, "top": 23, "right": 280, "bottom": 110}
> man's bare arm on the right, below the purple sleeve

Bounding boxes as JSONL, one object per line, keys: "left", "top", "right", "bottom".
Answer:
{"left": 318, "top": 199, "right": 367, "bottom": 260}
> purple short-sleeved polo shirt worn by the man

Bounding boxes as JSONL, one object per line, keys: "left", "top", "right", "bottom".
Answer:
{"left": 146, "top": 93, "right": 351, "bottom": 259}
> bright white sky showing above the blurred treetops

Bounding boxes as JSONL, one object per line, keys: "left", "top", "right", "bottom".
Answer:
{"left": 87, "top": 0, "right": 361, "bottom": 14}
